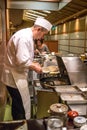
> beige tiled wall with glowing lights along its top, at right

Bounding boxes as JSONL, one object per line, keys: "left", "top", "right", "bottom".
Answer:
{"left": 47, "top": 16, "right": 87, "bottom": 54}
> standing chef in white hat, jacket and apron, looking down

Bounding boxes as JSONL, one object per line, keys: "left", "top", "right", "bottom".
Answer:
{"left": 1, "top": 18, "right": 52, "bottom": 120}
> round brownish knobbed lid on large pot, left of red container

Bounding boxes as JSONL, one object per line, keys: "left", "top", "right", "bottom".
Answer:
{"left": 50, "top": 103, "right": 68, "bottom": 113}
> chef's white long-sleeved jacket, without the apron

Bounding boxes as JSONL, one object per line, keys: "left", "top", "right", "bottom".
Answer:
{"left": 2, "top": 28, "right": 34, "bottom": 88}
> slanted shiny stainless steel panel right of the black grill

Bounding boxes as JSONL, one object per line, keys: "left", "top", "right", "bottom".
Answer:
{"left": 62, "top": 57, "right": 87, "bottom": 87}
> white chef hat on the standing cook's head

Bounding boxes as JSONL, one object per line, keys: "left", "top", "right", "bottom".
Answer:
{"left": 34, "top": 17, "right": 52, "bottom": 31}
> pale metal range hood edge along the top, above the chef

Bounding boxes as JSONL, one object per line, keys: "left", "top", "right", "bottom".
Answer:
{"left": 7, "top": 0, "right": 71, "bottom": 11}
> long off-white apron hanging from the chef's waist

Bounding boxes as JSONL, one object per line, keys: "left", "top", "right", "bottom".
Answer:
{"left": 11, "top": 70, "right": 31, "bottom": 120}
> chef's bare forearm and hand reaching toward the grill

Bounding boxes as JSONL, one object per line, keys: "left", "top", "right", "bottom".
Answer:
{"left": 29, "top": 62, "right": 42, "bottom": 73}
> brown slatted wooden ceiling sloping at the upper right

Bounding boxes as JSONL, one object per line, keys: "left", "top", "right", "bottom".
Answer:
{"left": 47, "top": 0, "right": 87, "bottom": 24}
